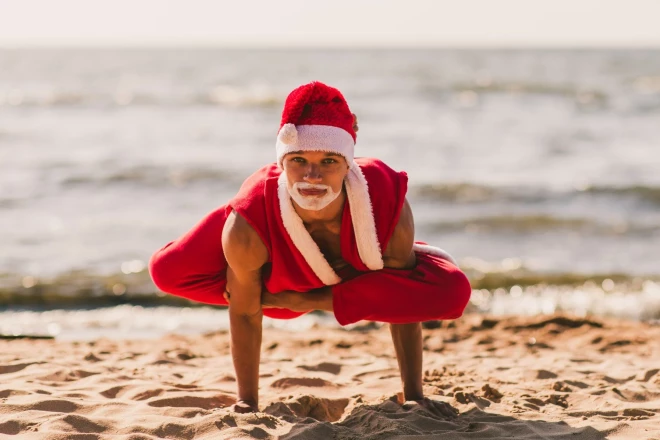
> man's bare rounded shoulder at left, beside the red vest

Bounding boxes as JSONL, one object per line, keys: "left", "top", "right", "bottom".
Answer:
{"left": 222, "top": 211, "right": 268, "bottom": 271}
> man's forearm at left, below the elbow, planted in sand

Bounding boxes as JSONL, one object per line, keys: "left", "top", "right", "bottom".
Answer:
{"left": 229, "top": 305, "right": 263, "bottom": 407}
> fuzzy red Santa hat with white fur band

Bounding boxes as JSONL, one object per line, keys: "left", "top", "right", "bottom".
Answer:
{"left": 276, "top": 81, "right": 356, "bottom": 167}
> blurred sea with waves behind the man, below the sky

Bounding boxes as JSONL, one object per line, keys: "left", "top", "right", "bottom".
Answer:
{"left": 0, "top": 49, "right": 660, "bottom": 333}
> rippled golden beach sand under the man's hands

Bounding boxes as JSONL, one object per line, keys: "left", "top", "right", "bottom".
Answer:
{"left": 0, "top": 315, "right": 660, "bottom": 440}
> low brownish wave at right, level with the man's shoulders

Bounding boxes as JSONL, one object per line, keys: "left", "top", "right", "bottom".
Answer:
{"left": 409, "top": 183, "right": 660, "bottom": 205}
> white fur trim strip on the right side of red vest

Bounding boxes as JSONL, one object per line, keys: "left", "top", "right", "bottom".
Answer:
{"left": 345, "top": 162, "right": 384, "bottom": 270}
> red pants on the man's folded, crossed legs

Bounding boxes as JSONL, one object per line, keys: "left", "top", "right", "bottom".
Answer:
{"left": 149, "top": 208, "right": 471, "bottom": 325}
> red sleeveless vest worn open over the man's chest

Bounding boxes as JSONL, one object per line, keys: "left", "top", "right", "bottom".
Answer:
{"left": 229, "top": 158, "right": 408, "bottom": 293}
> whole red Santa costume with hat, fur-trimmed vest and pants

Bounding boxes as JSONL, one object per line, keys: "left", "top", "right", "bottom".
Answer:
{"left": 149, "top": 82, "right": 471, "bottom": 325}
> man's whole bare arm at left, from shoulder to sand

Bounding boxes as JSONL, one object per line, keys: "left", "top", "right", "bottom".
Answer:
{"left": 222, "top": 212, "right": 268, "bottom": 412}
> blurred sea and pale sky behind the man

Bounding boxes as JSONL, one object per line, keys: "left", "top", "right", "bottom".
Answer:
{"left": 0, "top": 0, "right": 660, "bottom": 339}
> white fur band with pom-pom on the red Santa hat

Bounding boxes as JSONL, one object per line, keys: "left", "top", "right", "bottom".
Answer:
{"left": 275, "top": 124, "right": 355, "bottom": 167}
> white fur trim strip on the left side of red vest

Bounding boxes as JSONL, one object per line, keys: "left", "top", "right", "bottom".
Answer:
{"left": 277, "top": 172, "right": 341, "bottom": 286}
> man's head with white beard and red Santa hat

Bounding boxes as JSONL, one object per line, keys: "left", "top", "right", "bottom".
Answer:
{"left": 277, "top": 82, "right": 357, "bottom": 211}
